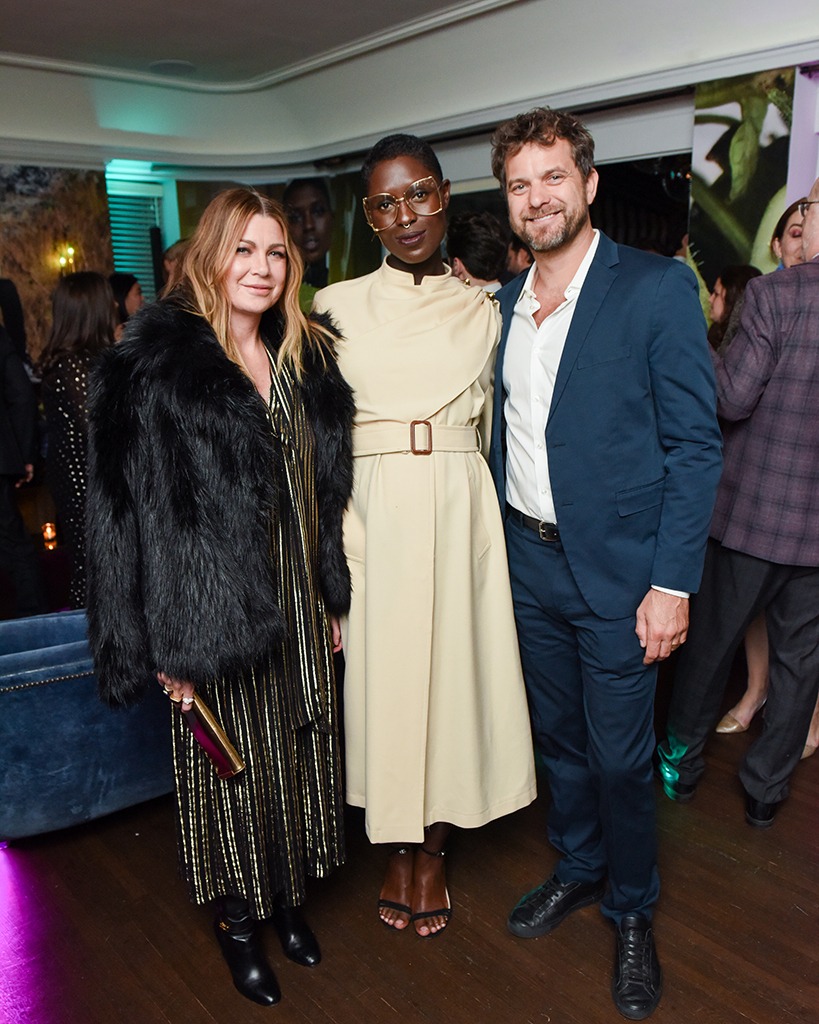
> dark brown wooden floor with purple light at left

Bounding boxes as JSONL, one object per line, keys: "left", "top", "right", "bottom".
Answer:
{"left": 0, "top": 671, "right": 819, "bottom": 1024}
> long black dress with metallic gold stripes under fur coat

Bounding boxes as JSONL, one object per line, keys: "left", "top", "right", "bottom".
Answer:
{"left": 173, "top": 359, "right": 344, "bottom": 920}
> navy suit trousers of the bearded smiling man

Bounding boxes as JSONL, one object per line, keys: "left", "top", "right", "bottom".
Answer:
{"left": 506, "top": 520, "right": 659, "bottom": 922}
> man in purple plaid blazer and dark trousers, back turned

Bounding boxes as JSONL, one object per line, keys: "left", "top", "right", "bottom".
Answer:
{"left": 657, "top": 179, "right": 819, "bottom": 828}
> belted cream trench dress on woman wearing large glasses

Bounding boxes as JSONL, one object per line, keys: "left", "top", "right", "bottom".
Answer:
{"left": 315, "top": 262, "right": 535, "bottom": 843}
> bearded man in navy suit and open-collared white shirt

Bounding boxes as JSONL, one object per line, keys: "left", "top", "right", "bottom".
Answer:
{"left": 490, "top": 110, "right": 721, "bottom": 1020}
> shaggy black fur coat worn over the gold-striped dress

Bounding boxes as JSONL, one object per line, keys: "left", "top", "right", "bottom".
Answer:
{"left": 86, "top": 300, "right": 354, "bottom": 703}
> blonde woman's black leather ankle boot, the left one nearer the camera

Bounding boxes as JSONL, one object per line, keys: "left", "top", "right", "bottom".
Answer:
{"left": 213, "top": 896, "right": 282, "bottom": 1007}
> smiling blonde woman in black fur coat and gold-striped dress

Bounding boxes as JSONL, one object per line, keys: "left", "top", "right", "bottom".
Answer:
{"left": 87, "top": 188, "right": 353, "bottom": 1006}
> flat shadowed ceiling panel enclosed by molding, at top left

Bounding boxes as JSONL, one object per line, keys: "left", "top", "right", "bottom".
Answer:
{"left": 0, "top": 0, "right": 518, "bottom": 90}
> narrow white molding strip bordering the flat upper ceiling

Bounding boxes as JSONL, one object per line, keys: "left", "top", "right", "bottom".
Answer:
{"left": 0, "top": 0, "right": 520, "bottom": 95}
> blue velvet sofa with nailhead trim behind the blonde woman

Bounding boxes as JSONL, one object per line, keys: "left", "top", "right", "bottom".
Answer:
{"left": 0, "top": 611, "right": 173, "bottom": 841}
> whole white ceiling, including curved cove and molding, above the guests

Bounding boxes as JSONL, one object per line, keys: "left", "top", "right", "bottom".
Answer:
{"left": 0, "top": 0, "right": 819, "bottom": 174}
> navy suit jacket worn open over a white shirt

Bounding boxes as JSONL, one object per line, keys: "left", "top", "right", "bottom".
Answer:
{"left": 489, "top": 233, "right": 722, "bottom": 618}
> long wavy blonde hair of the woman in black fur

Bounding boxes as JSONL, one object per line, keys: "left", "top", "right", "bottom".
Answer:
{"left": 178, "top": 188, "right": 334, "bottom": 379}
